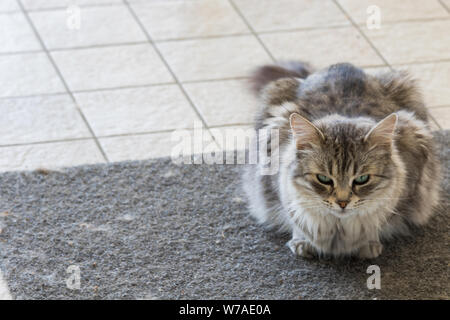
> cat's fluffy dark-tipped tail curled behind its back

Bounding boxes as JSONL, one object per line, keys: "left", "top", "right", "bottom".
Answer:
{"left": 250, "top": 61, "right": 314, "bottom": 95}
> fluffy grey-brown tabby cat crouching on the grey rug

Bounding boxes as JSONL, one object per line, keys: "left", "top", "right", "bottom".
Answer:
{"left": 243, "top": 62, "right": 440, "bottom": 259}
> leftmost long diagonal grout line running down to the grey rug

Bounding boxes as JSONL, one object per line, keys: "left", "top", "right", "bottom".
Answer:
{"left": 17, "top": 0, "right": 109, "bottom": 162}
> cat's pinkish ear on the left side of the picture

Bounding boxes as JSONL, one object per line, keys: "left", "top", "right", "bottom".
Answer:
{"left": 289, "top": 113, "right": 325, "bottom": 150}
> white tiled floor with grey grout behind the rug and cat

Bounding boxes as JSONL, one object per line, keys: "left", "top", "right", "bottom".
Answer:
{"left": 0, "top": 0, "right": 450, "bottom": 171}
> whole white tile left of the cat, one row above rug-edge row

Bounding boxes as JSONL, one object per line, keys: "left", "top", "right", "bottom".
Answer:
{"left": 75, "top": 85, "right": 200, "bottom": 136}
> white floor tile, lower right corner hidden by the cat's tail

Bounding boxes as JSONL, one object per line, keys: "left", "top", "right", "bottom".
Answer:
{"left": 157, "top": 36, "right": 271, "bottom": 81}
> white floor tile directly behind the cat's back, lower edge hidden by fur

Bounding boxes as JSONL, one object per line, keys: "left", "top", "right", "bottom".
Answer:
{"left": 261, "top": 27, "right": 384, "bottom": 67}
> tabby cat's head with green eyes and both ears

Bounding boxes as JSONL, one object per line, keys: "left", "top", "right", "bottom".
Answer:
{"left": 290, "top": 114, "right": 397, "bottom": 217}
